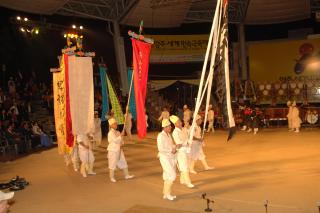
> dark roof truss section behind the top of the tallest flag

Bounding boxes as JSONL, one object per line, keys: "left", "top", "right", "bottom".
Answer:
{"left": 184, "top": 0, "right": 250, "bottom": 23}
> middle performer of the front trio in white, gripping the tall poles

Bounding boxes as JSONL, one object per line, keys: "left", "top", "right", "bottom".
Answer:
{"left": 170, "top": 115, "right": 194, "bottom": 188}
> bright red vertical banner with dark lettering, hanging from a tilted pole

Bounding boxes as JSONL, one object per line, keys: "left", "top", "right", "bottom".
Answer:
{"left": 131, "top": 39, "right": 151, "bottom": 138}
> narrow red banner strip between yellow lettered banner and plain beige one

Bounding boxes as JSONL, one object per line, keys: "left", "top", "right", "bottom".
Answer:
{"left": 63, "top": 54, "right": 74, "bottom": 147}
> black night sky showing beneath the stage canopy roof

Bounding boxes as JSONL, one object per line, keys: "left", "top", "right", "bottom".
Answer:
{"left": 0, "top": 7, "right": 320, "bottom": 85}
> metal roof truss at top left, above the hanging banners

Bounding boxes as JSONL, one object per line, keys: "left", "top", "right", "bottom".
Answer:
{"left": 57, "top": 0, "right": 138, "bottom": 22}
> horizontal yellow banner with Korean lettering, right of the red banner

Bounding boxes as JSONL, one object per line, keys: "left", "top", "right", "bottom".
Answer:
{"left": 146, "top": 34, "right": 209, "bottom": 63}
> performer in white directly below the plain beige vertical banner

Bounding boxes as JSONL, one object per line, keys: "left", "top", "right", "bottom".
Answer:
{"left": 77, "top": 134, "right": 96, "bottom": 177}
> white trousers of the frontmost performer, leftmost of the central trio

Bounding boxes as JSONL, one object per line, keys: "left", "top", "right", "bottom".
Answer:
{"left": 159, "top": 154, "right": 176, "bottom": 182}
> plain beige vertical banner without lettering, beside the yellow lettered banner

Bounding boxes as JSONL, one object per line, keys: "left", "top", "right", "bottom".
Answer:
{"left": 69, "top": 56, "right": 94, "bottom": 135}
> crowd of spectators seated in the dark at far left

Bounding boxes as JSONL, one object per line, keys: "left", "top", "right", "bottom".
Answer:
{"left": 0, "top": 76, "right": 53, "bottom": 160}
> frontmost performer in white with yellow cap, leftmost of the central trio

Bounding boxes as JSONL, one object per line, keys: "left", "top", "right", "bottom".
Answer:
{"left": 157, "top": 119, "right": 176, "bottom": 200}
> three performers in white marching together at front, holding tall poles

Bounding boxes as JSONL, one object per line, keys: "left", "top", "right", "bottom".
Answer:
{"left": 157, "top": 115, "right": 212, "bottom": 201}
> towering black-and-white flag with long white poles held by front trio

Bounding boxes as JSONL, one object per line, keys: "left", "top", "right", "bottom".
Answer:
{"left": 189, "top": 0, "right": 235, "bottom": 141}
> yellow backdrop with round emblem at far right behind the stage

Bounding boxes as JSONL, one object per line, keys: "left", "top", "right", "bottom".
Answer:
{"left": 248, "top": 38, "right": 320, "bottom": 82}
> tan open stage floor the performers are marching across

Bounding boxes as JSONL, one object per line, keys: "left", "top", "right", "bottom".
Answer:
{"left": 0, "top": 128, "right": 320, "bottom": 213}
